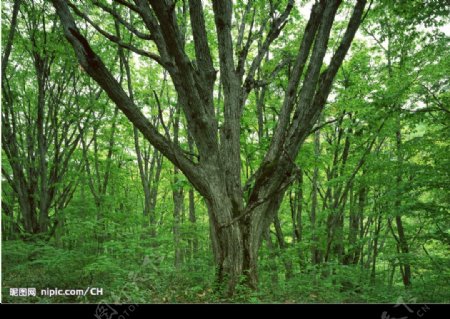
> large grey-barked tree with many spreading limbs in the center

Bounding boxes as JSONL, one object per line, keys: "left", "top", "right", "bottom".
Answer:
{"left": 52, "top": 0, "right": 366, "bottom": 294}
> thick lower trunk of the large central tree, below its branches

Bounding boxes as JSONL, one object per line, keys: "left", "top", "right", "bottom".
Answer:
{"left": 207, "top": 192, "right": 284, "bottom": 296}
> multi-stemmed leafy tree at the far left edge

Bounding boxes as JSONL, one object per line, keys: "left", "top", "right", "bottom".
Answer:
{"left": 2, "top": 1, "right": 90, "bottom": 237}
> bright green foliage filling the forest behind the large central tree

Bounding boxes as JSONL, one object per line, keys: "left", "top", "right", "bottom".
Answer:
{"left": 2, "top": 0, "right": 450, "bottom": 303}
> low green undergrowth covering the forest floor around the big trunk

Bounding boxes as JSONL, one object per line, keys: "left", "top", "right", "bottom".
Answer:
{"left": 2, "top": 241, "right": 450, "bottom": 303}
